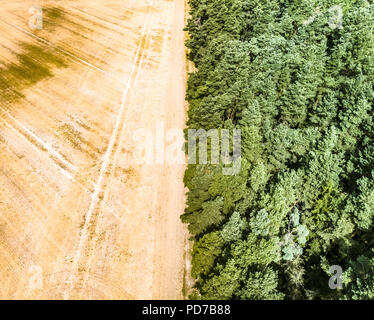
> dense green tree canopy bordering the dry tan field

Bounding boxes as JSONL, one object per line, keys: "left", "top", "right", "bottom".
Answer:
{"left": 182, "top": 0, "right": 374, "bottom": 299}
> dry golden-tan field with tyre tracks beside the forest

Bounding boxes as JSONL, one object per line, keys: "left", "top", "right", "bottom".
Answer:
{"left": 0, "top": 0, "right": 187, "bottom": 299}
